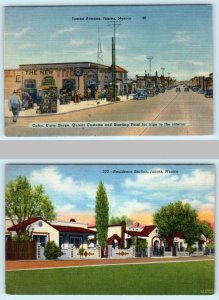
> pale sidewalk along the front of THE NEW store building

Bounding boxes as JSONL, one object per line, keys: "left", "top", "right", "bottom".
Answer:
{"left": 4, "top": 95, "right": 132, "bottom": 117}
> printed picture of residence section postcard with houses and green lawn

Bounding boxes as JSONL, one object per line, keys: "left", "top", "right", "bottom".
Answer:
{"left": 5, "top": 164, "right": 215, "bottom": 295}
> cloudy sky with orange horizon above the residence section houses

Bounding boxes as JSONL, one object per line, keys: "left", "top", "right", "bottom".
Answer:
{"left": 6, "top": 164, "right": 215, "bottom": 226}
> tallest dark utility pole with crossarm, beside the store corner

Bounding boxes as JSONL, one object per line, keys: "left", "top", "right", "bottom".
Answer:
{"left": 108, "top": 21, "right": 121, "bottom": 101}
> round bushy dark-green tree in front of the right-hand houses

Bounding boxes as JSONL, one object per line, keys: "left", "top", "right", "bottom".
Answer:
{"left": 153, "top": 201, "right": 200, "bottom": 253}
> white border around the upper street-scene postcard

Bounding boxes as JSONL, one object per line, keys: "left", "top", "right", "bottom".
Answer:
{"left": 0, "top": 0, "right": 219, "bottom": 141}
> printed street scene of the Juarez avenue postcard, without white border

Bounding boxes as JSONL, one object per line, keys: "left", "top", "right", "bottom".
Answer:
{"left": 4, "top": 4, "right": 214, "bottom": 137}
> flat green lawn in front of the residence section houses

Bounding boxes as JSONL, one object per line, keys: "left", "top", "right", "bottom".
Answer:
{"left": 6, "top": 261, "right": 214, "bottom": 295}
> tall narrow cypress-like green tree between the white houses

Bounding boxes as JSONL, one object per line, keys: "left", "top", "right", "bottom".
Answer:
{"left": 95, "top": 181, "right": 109, "bottom": 256}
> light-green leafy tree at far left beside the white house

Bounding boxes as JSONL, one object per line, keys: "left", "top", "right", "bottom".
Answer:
{"left": 5, "top": 176, "right": 56, "bottom": 239}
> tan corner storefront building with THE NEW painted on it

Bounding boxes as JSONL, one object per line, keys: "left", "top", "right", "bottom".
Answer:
{"left": 5, "top": 62, "right": 128, "bottom": 99}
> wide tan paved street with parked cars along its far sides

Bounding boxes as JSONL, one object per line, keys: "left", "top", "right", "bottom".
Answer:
{"left": 5, "top": 89, "right": 213, "bottom": 136}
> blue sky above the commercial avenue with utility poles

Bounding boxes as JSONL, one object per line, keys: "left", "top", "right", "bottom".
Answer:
{"left": 4, "top": 5, "right": 213, "bottom": 80}
